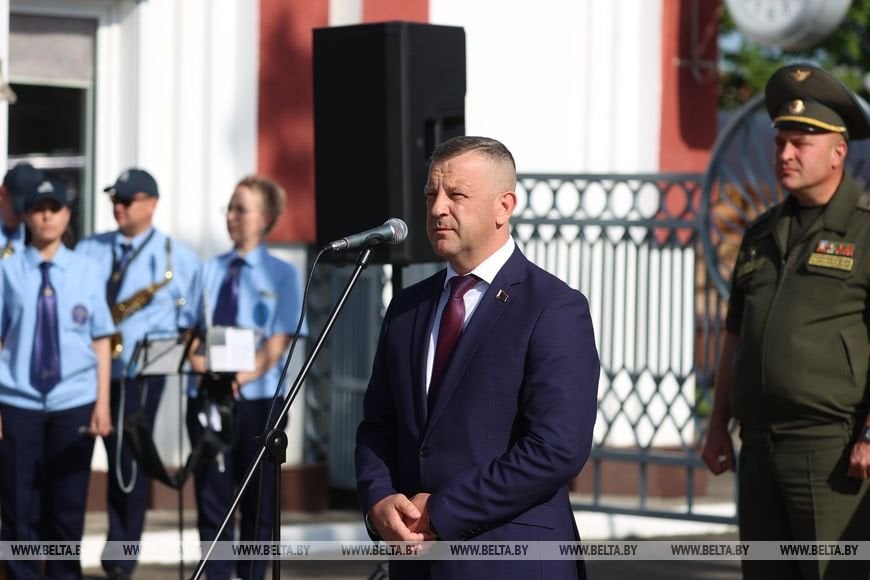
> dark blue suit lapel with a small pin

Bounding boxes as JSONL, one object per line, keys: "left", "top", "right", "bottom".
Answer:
{"left": 424, "top": 249, "right": 528, "bottom": 431}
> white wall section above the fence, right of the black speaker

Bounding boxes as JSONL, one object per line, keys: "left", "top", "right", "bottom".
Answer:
{"left": 430, "top": 0, "right": 661, "bottom": 172}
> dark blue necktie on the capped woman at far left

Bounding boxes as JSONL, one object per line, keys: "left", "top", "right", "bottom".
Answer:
{"left": 30, "top": 262, "right": 60, "bottom": 394}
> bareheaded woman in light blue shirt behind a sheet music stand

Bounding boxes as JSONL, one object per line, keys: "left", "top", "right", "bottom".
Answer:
{"left": 182, "top": 176, "right": 306, "bottom": 580}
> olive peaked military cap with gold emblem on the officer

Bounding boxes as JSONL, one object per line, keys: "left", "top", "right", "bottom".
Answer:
{"left": 764, "top": 64, "right": 870, "bottom": 139}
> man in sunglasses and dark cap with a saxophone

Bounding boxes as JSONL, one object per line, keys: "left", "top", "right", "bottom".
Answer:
{"left": 76, "top": 168, "right": 199, "bottom": 578}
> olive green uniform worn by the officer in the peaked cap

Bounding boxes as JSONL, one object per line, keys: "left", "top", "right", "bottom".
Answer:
{"left": 727, "top": 177, "right": 870, "bottom": 579}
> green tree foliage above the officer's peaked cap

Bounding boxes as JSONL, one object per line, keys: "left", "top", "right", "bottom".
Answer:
{"left": 719, "top": 0, "right": 870, "bottom": 109}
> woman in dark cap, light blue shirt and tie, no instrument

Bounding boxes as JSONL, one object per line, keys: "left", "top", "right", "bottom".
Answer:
{"left": 0, "top": 180, "right": 115, "bottom": 578}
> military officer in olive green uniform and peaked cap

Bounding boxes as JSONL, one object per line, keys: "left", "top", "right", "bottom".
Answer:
{"left": 702, "top": 64, "right": 870, "bottom": 579}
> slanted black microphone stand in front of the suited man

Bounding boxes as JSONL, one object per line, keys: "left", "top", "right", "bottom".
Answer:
{"left": 191, "top": 246, "right": 372, "bottom": 580}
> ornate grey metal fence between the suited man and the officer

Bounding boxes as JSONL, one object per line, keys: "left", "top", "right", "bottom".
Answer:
{"left": 513, "top": 173, "right": 735, "bottom": 523}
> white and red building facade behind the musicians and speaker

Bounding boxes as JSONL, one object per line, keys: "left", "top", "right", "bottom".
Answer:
{"left": 0, "top": 0, "right": 719, "bottom": 508}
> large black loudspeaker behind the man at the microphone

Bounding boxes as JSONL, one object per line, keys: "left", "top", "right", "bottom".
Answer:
{"left": 314, "top": 22, "right": 465, "bottom": 265}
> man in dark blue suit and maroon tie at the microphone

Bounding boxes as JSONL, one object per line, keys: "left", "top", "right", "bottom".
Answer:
{"left": 356, "top": 137, "right": 599, "bottom": 580}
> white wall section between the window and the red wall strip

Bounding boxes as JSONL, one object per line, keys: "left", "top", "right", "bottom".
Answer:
{"left": 124, "top": 0, "right": 259, "bottom": 256}
